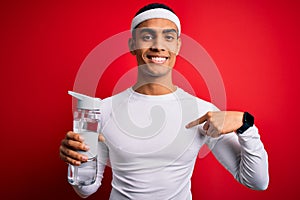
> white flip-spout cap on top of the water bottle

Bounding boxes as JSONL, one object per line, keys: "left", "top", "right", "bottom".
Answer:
{"left": 68, "top": 91, "right": 101, "bottom": 110}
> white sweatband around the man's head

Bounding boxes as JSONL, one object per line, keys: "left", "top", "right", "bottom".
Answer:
{"left": 131, "top": 8, "right": 181, "bottom": 36}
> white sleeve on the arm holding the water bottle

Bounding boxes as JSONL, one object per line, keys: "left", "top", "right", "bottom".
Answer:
{"left": 73, "top": 142, "right": 108, "bottom": 198}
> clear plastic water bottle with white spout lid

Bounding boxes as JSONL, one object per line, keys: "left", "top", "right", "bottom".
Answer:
{"left": 68, "top": 91, "right": 101, "bottom": 185}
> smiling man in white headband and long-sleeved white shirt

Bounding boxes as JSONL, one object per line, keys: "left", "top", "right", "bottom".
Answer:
{"left": 60, "top": 4, "right": 269, "bottom": 200}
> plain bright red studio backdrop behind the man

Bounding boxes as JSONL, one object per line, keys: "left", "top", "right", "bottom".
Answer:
{"left": 0, "top": 0, "right": 300, "bottom": 200}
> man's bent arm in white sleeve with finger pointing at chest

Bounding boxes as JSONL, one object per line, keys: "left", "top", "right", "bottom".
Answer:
{"left": 187, "top": 111, "right": 269, "bottom": 190}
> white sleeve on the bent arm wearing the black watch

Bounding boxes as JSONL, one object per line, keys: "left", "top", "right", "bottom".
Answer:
{"left": 208, "top": 126, "right": 269, "bottom": 190}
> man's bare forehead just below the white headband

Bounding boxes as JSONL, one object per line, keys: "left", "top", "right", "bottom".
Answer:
{"left": 137, "top": 18, "right": 178, "bottom": 32}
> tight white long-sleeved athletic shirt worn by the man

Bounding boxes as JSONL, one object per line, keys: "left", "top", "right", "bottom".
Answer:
{"left": 74, "top": 88, "right": 269, "bottom": 200}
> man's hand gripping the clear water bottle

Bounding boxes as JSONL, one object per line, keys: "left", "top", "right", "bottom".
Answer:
{"left": 59, "top": 131, "right": 89, "bottom": 166}
